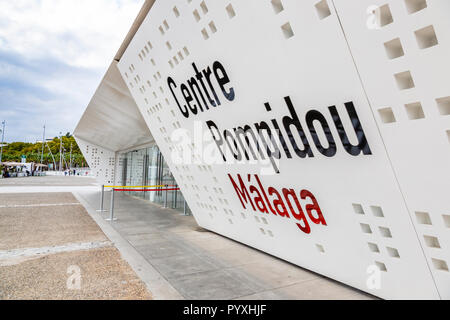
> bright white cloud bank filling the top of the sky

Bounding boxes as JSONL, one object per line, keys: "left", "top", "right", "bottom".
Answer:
{"left": 0, "top": 0, "right": 143, "bottom": 68}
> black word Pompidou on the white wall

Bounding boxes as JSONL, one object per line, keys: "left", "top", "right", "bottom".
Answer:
{"left": 206, "top": 96, "right": 372, "bottom": 173}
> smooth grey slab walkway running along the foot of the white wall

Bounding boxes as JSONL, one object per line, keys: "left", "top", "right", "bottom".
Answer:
{"left": 75, "top": 192, "right": 374, "bottom": 300}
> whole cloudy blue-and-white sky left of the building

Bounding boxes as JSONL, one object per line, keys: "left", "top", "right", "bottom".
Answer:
{"left": 0, "top": 0, "right": 144, "bottom": 142}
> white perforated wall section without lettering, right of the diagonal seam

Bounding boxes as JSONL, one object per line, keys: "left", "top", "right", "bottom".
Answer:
{"left": 335, "top": 0, "right": 450, "bottom": 299}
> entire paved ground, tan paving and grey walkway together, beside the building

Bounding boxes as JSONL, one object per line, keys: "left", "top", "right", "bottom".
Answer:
{"left": 0, "top": 177, "right": 373, "bottom": 300}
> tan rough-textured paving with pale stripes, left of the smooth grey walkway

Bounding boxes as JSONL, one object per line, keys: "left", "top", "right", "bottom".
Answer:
{"left": 0, "top": 192, "right": 151, "bottom": 300}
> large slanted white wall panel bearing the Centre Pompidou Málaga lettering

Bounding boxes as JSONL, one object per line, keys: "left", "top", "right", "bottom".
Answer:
{"left": 118, "top": 0, "right": 438, "bottom": 298}
